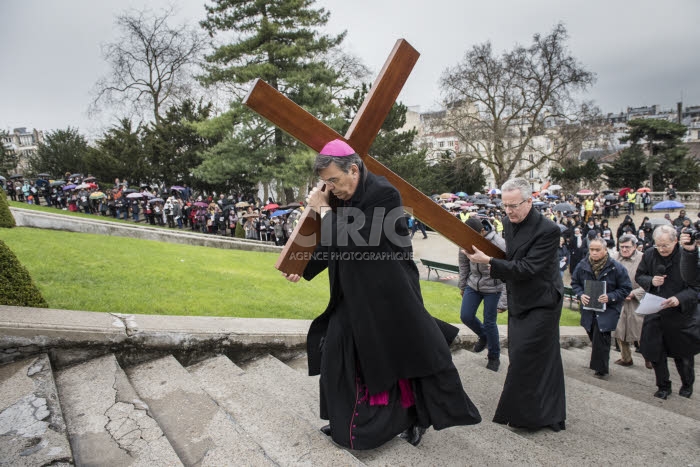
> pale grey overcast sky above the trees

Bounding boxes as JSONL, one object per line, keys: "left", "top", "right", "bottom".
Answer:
{"left": 0, "top": 0, "right": 700, "bottom": 135}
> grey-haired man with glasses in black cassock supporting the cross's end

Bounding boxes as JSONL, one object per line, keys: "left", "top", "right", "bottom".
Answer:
{"left": 467, "top": 178, "right": 566, "bottom": 431}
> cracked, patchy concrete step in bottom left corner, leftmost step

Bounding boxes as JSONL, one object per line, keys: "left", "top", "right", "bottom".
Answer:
{"left": 0, "top": 354, "right": 73, "bottom": 466}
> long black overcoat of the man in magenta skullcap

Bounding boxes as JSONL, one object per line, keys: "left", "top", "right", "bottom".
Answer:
{"left": 303, "top": 168, "right": 458, "bottom": 394}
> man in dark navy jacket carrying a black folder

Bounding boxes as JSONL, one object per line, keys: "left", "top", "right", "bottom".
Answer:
{"left": 571, "top": 238, "right": 632, "bottom": 379}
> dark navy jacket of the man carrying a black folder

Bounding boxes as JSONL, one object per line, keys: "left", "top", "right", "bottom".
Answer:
{"left": 571, "top": 257, "right": 632, "bottom": 332}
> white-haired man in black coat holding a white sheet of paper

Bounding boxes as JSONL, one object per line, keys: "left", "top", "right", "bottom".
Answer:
{"left": 635, "top": 225, "right": 700, "bottom": 399}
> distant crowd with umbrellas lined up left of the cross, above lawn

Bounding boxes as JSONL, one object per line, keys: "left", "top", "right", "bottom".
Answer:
{"left": 4, "top": 173, "right": 301, "bottom": 245}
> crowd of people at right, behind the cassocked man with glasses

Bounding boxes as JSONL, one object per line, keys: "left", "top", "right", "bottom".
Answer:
{"left": 450, "top": 187, "right": 700, "bottom": 399}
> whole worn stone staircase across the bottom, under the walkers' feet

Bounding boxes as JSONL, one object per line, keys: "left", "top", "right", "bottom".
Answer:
{"left": 0, "top": 348, "right": 700, "bottom": 466}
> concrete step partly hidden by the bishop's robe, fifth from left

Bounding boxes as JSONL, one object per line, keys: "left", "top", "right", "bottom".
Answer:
{"left": 242, "top": 356, "right": 434, "bottom": 466}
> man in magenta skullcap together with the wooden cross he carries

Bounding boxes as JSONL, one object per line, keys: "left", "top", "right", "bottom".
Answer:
{"left": 245, "top": 41, "right": 490, "bottom": 449}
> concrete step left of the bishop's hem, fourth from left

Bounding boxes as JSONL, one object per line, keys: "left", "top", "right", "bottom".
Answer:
{"left": 187, "top": 356, "right": 362, "bottom": 466}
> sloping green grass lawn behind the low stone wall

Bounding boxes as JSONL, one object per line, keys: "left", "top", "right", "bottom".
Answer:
{"left": 0, "top": 227, "right": 579, "bottom": 326}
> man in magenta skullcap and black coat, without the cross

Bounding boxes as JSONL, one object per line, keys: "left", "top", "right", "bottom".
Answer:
{"left": 285, "top": 140, "right": 481, "bottom": 449}
